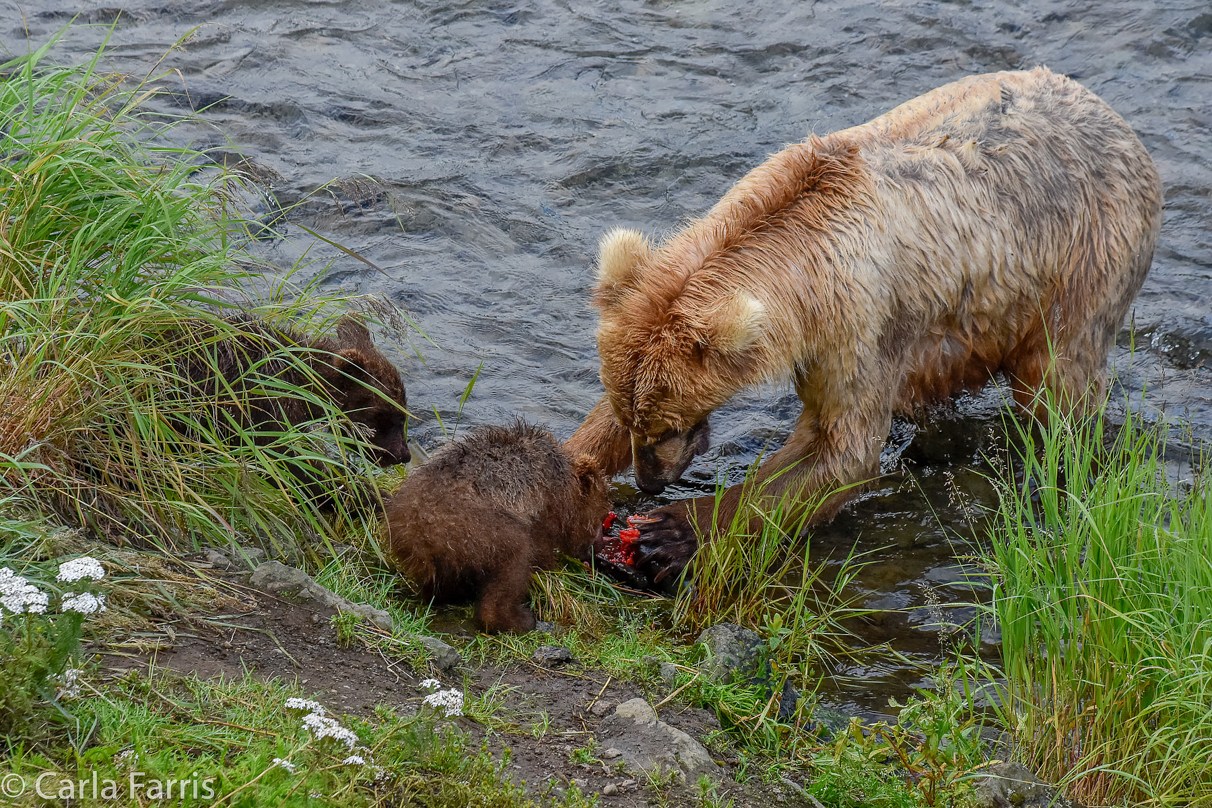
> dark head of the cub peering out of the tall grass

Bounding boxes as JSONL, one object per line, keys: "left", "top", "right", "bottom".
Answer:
{"left": 332, "top": 315, "right": 412, "bottom": 466}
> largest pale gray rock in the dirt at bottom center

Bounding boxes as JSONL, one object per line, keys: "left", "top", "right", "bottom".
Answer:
{"left": 598, "top": 699, "right": 722, "bottom": 783}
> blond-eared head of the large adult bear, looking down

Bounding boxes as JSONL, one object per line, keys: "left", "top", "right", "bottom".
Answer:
{"left": 595, "top": 229, "right": 766, "bottom": 493}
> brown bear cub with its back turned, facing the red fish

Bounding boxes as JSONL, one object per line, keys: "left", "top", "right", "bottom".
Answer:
{"left": 387, "top": 420, "right": 610, "bottom": 632}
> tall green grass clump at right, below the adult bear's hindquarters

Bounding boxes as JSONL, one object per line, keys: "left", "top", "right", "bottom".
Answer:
{"left": 991, "top": 397, "right": 1212, "bottom": 806}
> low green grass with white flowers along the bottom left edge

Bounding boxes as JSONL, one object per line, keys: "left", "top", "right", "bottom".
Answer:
{"left": 6, "top": 671, "right": 594, "bottom": 808}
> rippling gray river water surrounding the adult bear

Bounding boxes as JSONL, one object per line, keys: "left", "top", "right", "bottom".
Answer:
{"left": 0, "top": 0, "right": 1212, "bottom": 710}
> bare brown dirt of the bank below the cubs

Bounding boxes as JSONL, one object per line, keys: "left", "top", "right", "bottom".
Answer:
{"left": 102, "top": 574, "right": 785, "bottom": 808}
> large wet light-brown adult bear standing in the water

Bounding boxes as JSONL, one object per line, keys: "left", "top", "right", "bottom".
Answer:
{"left": 570, "top": 68, "right": 1161, "bottom": 580}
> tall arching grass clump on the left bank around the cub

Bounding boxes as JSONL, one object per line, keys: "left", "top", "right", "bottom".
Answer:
{"left": 0, "top": 37, "right": 402, "bottom": 550}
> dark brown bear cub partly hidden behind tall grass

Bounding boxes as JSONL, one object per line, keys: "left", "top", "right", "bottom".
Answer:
{"left": 182, "top": 315, "right": 411, "bottom": 466}
